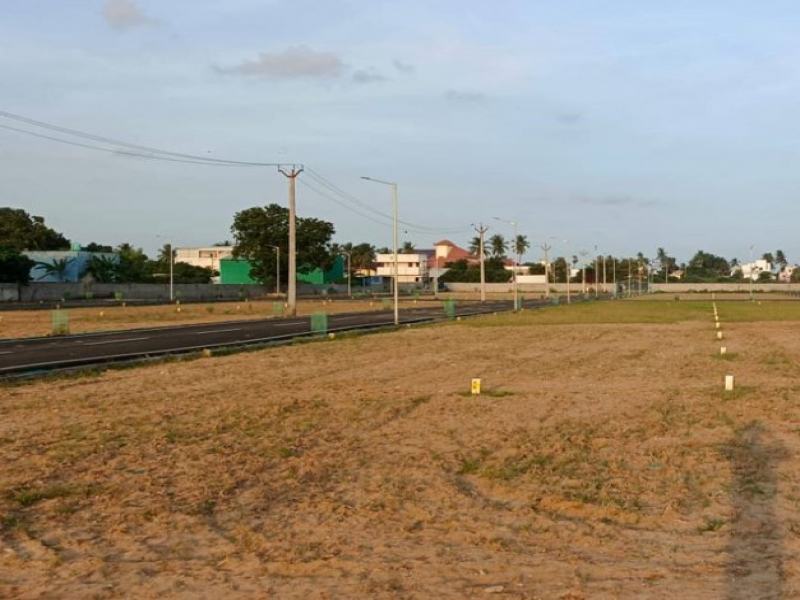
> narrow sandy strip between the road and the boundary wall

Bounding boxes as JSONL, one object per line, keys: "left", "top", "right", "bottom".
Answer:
{"left": 0, "top": 298, "right": 436, "bottom": 339}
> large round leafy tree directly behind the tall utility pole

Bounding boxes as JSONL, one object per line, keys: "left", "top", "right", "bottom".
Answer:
{"left": 231, "top": 204, "right": 336, "bottom": 283}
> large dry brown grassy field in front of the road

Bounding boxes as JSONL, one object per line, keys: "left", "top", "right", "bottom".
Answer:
{"left": 0, "top": 301, "right": 800, "bottom": 600}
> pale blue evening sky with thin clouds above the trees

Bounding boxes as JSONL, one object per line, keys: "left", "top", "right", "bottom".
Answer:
{"left": 0, "top": 0, "right": 800, "bottom": 262}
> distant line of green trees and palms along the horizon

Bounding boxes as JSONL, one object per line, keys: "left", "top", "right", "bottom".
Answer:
{"left": 0, "top": 203, "right": 800, "bottom": 284}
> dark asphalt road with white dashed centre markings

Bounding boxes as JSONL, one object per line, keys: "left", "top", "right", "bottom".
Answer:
{"left": 0, "top": 301, "right": 545, "bottom": 376}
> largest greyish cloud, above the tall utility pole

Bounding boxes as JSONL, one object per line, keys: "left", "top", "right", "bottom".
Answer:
{"left": 216, "top": 46, "right": 345, "bottom": 79}
